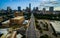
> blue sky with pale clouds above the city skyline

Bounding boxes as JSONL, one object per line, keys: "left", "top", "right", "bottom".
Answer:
{"left": 0, "top": 0, "right": 60, "bottom": 10}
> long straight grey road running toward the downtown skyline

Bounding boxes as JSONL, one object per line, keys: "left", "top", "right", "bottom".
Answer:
{"left": 26, "top": 14, "right": 38, "bottom": 38}
